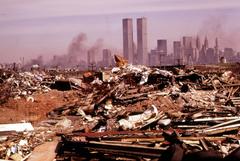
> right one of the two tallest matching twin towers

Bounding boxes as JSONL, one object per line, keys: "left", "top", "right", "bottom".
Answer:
{"left": 137, "top": 17, "right": 148, "bottom": 65}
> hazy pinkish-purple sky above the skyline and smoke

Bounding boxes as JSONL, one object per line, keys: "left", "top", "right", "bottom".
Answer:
{"left": 0, "top": 0, "right": 240, "bottom": 63}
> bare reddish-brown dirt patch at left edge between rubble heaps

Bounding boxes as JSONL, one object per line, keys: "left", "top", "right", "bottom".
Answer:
{"left": 0, "top": 90, "right": 78, "bottom": 123}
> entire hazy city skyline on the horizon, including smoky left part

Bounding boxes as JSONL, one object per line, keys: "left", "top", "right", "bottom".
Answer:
{"left": 6, "top": 17, "right": 240, "bottom": 70}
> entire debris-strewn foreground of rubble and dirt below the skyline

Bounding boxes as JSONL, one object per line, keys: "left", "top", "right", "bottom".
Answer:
{"left": 0, "top": 55, "right": 240, "bottom": 161}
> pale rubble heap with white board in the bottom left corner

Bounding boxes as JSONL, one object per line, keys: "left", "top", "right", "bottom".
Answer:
{"left": 0, "top": 123, "right": 55, "bottom": 161}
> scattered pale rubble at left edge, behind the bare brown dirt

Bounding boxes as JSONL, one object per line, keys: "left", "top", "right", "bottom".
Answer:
{"left": 0, "top": 70, "right": 54, "bottom": 103}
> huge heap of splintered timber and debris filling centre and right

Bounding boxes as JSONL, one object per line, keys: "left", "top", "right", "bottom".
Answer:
{"left": 0, "top": 56, "right": 240, "bottom": 161}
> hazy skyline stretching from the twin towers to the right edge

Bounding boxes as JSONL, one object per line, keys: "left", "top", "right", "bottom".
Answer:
{"left": 122, "top": 17, "right": 240, "bottom": 66}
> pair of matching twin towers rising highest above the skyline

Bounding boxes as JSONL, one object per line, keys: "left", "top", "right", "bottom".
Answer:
{"left": 122, "top": 17, "right": 148, "bottom": 65}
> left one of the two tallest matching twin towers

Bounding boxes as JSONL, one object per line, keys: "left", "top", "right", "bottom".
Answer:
{"left": 122, "top": 18, "right": 133, "bottom": 63}
